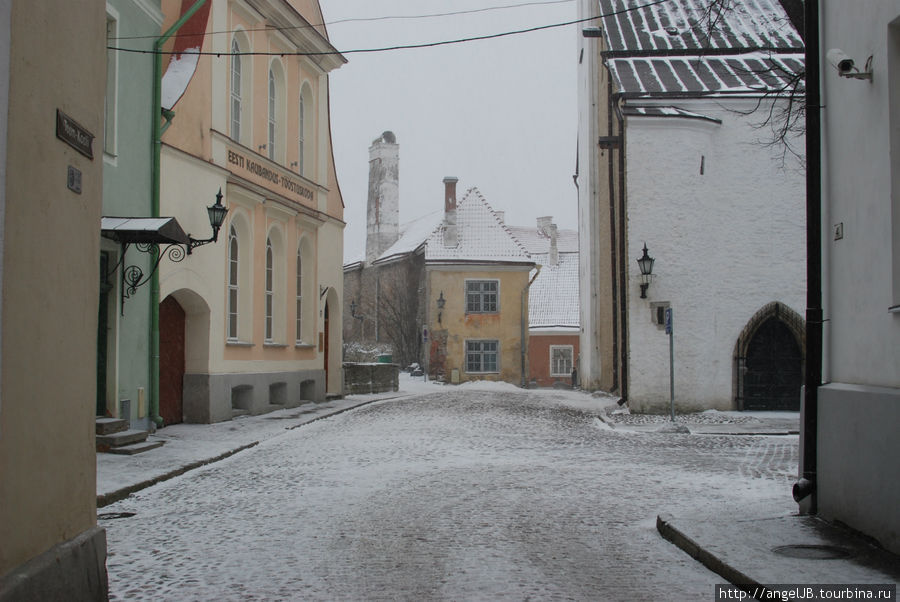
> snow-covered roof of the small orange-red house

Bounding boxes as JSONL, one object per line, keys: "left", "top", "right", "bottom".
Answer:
{"left": 528, "top": 252, "right": 580, "bottom": 329}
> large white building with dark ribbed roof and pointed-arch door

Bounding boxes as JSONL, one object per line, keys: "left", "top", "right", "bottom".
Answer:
{"left": 578, "top": 0, "right": 806, "bottom": 411}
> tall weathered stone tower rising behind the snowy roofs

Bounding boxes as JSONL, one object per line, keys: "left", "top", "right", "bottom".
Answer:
{"left": 366, "top": 132, "right": 400, "bottom": 263}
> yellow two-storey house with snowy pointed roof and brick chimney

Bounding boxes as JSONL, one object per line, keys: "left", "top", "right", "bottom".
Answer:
{"left": 425, "top": 178, "right": 535, "bottom": 385}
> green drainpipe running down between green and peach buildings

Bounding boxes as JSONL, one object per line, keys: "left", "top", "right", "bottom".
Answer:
{"left": 149, "top": 0, "right": 207, "bottom": 427}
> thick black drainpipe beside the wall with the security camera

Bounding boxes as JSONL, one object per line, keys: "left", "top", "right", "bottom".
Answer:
{"left": 793, "top": 0, "right": 823, "bottom": 514}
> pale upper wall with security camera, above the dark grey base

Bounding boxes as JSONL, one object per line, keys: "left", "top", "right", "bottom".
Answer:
{"left": 821, "top": 0, "right": 900, "bottom": 387}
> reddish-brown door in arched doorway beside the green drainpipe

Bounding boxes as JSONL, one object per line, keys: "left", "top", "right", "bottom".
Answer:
{"left": 159, "top": 295, "right": 185, "bottom": 425}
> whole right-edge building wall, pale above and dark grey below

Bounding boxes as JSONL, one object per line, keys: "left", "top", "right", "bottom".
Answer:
{"left": 817, "top": 0, "right": 900, "bottom": 553}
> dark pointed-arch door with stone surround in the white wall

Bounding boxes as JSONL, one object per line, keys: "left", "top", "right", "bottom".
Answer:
{"left": 734, "top": 301, "right": 806, "bottom": 411}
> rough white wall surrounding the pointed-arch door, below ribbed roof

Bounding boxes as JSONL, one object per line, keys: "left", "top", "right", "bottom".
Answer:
{"left": 626, "top": 100, "right": 806, "bottom": 410}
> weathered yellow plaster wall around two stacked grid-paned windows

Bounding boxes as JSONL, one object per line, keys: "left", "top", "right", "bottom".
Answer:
{"left": 427, "top": 267, "right": 528, "bottom": 384}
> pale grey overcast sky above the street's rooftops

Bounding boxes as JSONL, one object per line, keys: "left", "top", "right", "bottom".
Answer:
{"left": 320, "top": 0, "right": 579, "bottom": 261}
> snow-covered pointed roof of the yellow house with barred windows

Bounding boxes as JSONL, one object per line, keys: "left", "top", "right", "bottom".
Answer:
{"left": 425, "top": 188, "right": 533, "bottom": 263}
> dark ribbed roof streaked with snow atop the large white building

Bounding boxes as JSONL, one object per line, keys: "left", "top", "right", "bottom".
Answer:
{"left": 600, "top": 0, "right": 804, "bottom": 97}
